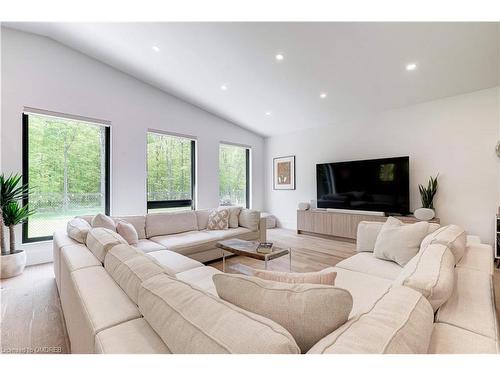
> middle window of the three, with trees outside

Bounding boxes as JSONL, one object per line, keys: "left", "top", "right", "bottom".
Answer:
{"left": 147, "top": 132, "right": 195, "bottom": 212}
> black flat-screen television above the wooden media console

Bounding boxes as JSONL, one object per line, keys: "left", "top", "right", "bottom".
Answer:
{"left": 316, "top": 156, "right": 410, "bottom": 215}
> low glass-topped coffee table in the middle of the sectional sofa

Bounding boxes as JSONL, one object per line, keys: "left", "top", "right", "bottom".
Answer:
{"left": 215, "top": 238, "right": 292, "bottom": 272}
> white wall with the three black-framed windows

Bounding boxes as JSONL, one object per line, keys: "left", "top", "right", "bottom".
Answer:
{"left": 0, "top": 28, "right": 264, "bottom": 263}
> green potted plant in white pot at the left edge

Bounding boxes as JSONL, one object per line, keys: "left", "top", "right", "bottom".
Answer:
{"left": 0, "top": 174, "right": 34, "bottom": 279}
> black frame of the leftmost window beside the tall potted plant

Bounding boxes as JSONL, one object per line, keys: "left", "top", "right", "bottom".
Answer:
{"left": 21, "top": 112, "right": 111, "bottom": 243}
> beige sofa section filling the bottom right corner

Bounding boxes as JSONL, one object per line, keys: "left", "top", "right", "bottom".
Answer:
{"left": 429, "top": 323, "right": 498, "bottom": 354}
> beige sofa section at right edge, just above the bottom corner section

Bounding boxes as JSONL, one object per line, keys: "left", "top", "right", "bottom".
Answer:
{"left": 436, "top": 268, "right": 499, "bottom": 340}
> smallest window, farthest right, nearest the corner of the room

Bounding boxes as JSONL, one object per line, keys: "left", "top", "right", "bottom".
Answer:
{"left": 219, "top": 143, "right": 250, "bottom": 208}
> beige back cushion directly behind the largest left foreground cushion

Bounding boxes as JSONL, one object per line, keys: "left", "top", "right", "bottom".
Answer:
{"left": 104, "top": 245, "right": 165, "bottom": 304}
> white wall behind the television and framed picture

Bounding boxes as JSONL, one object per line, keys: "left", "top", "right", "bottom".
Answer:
{"left": 265, "top": 88, "right": 500, "bottom": 243}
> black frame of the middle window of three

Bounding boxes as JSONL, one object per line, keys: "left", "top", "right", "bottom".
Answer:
{"left": 146, "top": 134, "right": 196, "bottom": 213}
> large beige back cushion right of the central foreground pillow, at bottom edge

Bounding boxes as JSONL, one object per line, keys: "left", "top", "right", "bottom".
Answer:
{"left": 309, "top": 287, "right": 434, "bottom": 354}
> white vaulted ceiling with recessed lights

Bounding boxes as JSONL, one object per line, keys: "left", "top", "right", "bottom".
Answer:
{"left": 7, "top": 22, "right": 500, "bottom": 136}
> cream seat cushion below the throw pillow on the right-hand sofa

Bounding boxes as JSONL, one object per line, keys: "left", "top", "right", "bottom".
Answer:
{"left": 335, "top": 252, "right": 403, "bottom": 280}
